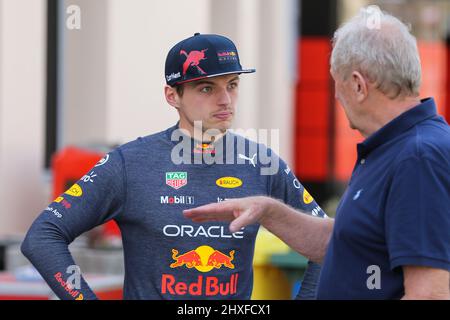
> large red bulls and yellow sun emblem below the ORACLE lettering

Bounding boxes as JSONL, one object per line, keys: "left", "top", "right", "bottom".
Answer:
{"left": 170, "top": 246, "right": 235, "bottom": 272}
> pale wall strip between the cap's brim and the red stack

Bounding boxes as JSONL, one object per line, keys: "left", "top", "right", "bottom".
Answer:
{"left": 257, "top": 0, "right": 298, "bottom": 161}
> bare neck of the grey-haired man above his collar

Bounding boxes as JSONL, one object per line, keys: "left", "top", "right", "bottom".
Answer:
{"left": 359, "top": 96, "right": 421, "bottom": 138}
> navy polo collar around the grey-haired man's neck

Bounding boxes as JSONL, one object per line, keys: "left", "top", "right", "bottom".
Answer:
{"left": 358, "top": 98, "right": 437, "bottom": 157}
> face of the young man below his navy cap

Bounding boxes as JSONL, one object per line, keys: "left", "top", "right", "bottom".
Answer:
{"left": 166, "top": 74, "right": 243, "bottom": 132}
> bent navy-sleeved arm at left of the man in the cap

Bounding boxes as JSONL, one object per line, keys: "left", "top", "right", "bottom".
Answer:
{"left": 21, "top": 151, "right": 125, "bottom": 300}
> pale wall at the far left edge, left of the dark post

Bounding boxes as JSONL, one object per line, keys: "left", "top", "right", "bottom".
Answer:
{"left": 0, "top": 0, "right": 48, "bottom": 236}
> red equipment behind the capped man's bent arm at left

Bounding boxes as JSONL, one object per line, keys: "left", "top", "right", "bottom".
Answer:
{"left": 52, "top": 147, "right": 120, "bottom": 236}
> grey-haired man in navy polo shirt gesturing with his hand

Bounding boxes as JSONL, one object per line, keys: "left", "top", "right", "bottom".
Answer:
{"left": 185, "top": 9, "right": 450, "bottom": 299}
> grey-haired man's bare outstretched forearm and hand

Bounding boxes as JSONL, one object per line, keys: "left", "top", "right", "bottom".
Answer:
{"left": 184, "top": 197, "right": 334, "bottom": 263}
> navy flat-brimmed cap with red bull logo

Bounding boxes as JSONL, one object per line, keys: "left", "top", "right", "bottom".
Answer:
{"left": 165, "top": 33, "right": 256, "bottom": 87}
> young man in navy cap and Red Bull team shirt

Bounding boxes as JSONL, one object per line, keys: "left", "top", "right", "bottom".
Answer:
{"left": 22, "top": 34, "right": 324, "bottom": 300}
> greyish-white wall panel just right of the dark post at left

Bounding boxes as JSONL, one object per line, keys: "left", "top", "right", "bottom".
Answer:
{"left": 60, "top": 0, "right": 109, "bottom": 146}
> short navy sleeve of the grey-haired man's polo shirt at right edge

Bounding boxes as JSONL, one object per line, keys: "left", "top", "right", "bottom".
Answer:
{"left": 384, "top": 157, "right": 450, "bottom": 270}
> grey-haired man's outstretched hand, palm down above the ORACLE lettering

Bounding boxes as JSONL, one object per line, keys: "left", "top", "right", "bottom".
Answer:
{"left": 183, "top": 197, "right": 275, "bottom": 233}
